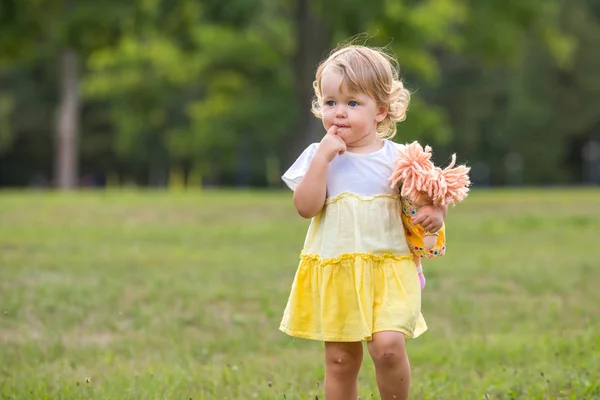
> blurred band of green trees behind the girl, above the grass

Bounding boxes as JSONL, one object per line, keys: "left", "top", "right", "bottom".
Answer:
{"left": 0, "top": 0, "right": 600, "bottom": 188}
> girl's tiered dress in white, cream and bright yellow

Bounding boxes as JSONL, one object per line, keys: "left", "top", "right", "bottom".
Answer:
{"left": 280, "top": 141, "right": 427, "bottom": 342}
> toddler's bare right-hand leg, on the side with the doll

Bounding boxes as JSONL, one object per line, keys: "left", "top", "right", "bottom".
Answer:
{"left": 367, "top": 331, "right": 410, "bottom": 400}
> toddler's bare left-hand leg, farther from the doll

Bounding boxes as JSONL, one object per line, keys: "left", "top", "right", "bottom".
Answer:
{"left": 325, "top": 342, "right": 363, "bottom": 400}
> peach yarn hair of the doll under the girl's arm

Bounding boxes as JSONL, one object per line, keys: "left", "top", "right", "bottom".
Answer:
{"left": 390, "top": 141, "right": 471, "bottom": 206}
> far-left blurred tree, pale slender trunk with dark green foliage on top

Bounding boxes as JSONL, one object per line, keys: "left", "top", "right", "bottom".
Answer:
{"left": 0, "top": 0, "right": 137, "bottom": 189}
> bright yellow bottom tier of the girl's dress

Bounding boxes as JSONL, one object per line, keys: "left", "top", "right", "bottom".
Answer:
{"left": 280, "top": 253, "right": 427, "bottom": 342}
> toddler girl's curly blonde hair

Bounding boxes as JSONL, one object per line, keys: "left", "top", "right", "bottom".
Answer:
{"left": 311, "top": 45, "right": 410, "bottom": 139}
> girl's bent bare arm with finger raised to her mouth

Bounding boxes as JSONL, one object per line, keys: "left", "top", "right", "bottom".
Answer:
{"left": 294, "top": 125, "right": 346, "bottom": 218}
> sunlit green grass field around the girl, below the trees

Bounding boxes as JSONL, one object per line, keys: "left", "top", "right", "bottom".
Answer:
{"left": 0, "top": 189, "right": 600, "bottom": 400}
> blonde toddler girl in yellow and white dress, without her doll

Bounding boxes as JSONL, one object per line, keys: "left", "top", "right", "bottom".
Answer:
{"left": 280, "top": 46, "right": 445, "bottom": 400}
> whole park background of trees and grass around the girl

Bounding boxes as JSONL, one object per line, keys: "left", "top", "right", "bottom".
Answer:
{"left": 0, "top": 0, "right": 600, "bottom": 400}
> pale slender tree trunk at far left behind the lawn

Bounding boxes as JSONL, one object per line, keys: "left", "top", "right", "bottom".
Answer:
{"left": 55, "top": 48, "right": 80, "bottom": 189}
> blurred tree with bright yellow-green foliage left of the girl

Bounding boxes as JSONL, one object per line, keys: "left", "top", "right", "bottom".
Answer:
{"left": 85, "top": 0, "right": 291, "bottom": 184}
